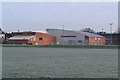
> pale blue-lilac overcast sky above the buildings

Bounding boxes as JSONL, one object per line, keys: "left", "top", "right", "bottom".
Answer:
{"left": 2, "top": 2, "right": 118, "bottom": 32}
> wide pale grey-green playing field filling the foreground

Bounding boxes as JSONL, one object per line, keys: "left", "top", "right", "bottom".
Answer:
{"left": 2, "top": 47, "right": 118, "bottom": 78}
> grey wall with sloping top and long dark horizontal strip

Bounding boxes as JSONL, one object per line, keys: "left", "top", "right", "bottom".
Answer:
{"left": 47, "top": 29, "right": 85, "bottom": 45}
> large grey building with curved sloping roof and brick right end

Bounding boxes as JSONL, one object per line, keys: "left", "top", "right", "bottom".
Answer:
{"left": 46, "top": 29, "right": 106, "bottom": 45}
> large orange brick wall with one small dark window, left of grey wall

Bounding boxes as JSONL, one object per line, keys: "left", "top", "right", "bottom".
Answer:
{"left": 28, "top": 32, "right": 56, "bottom": 45}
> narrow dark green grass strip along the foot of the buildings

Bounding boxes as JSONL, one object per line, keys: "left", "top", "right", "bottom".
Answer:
{"left": 1, "top": 44, "right": 120, "bottom": 49}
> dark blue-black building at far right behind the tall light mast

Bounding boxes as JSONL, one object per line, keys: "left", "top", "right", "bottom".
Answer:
{"left": 97, "top": 32, "right": 120, "bottom": 45}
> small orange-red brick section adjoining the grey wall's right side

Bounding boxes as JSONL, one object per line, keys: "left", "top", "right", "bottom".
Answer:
{"left": 86, "top": 37, "right": 106, "bottom": 45}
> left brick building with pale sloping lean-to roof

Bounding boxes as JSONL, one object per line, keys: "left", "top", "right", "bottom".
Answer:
{"left": 8, "top": 32, "right": 56, "bottom": 45}
